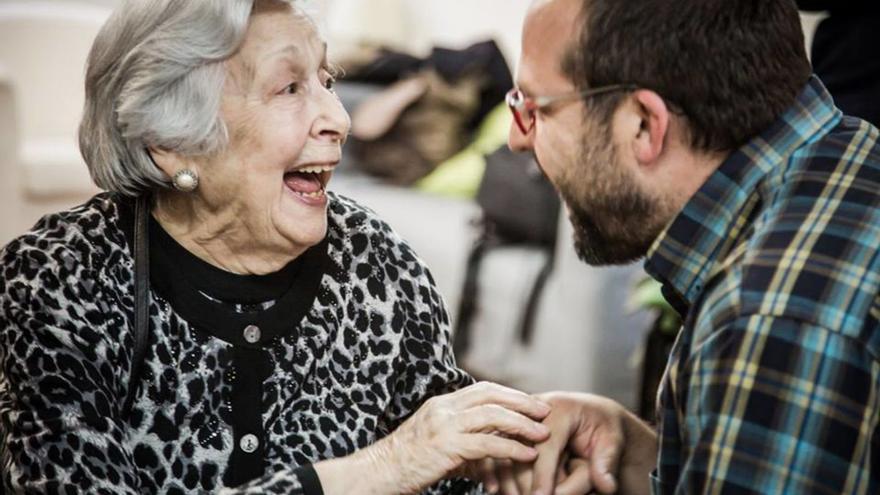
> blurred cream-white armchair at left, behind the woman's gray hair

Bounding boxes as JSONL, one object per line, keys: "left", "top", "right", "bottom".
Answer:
{"left": 0, "top": 1, "right": 110, "bottom": 245}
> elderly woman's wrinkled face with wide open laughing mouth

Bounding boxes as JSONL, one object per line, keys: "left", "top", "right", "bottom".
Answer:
{"left": 199, "top": 1, "right": 350, "bottom": 253}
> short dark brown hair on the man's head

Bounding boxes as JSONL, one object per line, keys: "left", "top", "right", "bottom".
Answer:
{"left": 562, "top": 0, "right": 812, "bottom": 151}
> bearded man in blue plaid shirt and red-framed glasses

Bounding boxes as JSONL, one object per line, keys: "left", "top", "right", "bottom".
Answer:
{"left": 490, "top": 0, "right": 880, "bottom": 495}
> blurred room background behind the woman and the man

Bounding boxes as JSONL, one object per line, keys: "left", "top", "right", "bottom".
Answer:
{"left": 0, "top": 0, "right": 824, "bottom": 411}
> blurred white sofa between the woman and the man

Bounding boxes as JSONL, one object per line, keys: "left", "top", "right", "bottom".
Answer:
{"left": 330, "top": 176, "right": 652, "bottom": 407}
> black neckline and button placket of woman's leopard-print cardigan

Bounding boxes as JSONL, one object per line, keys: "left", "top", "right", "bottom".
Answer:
{"left": 120, "top": 198, "right": 327, "bottom": 491}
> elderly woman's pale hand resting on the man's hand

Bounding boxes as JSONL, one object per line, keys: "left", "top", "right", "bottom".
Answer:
{"left": 315, "top": 382, "right": 550, "bottom": 495}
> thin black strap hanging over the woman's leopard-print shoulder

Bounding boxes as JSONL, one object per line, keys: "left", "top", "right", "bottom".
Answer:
{"left": 122, "top": 195, "right": 150, "bottom": 418}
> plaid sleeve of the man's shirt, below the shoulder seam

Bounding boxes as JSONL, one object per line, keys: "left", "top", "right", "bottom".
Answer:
{"left": 675, "top": 315, "right": 880, "bottom": 494}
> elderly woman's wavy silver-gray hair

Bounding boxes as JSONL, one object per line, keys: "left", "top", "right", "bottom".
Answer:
{"left": 79, "top": 0, "right": 302, "bottom": 195}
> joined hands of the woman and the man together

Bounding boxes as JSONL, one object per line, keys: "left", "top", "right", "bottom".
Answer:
{"left": 342, "top": 383, "right": 656, "bottom": 495}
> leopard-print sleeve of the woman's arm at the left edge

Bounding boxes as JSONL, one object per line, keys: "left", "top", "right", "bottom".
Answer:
{"left": 0, "top": 246, "right": 138, "bottom": 494}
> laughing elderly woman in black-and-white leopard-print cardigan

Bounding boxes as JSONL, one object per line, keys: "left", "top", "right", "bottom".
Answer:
{"left": 0, "top": 0, "right": 549, "bottom": 494}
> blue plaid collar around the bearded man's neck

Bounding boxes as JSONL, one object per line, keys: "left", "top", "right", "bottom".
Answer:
{"left": 645, "top": 76, "right": 842, "bottom": 307}
